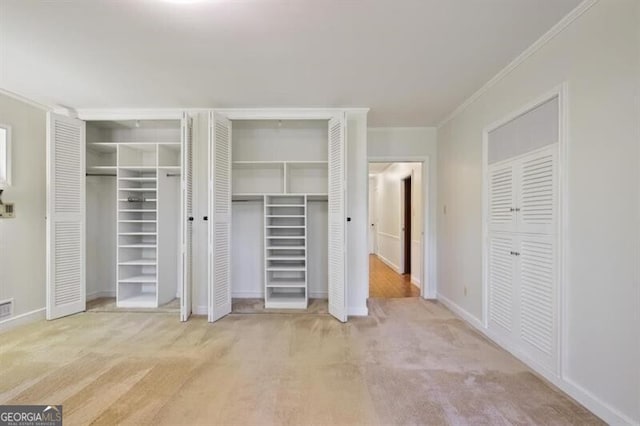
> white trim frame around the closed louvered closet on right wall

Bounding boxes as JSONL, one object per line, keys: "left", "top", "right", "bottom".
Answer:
{"left": 481, "top": 82, "right": 569, "bottom": 377}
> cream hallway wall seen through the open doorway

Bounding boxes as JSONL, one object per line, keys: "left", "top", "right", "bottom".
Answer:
{"left": 373, "top": 163, "right": 423, "bottom": 285}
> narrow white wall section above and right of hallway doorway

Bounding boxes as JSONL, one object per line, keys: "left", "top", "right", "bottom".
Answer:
{"left": 367, "top": 127, "right": 437, "bottom": 298}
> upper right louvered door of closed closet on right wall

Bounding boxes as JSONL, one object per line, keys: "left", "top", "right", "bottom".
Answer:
{"left": 517, "top": 144, "right": 557, "bottom": 235}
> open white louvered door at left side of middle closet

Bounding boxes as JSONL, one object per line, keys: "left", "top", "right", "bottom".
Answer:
{"left": 209, "top": 113, "right": 231, "bottom": 322}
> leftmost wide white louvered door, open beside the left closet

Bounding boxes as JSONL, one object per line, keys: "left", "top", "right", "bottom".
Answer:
{"left": 47, "top": 113, "right": 86, "bottom": 319}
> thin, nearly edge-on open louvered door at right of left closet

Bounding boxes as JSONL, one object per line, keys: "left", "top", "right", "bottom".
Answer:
{"left": 180, "top": 114, "right": 193, "bottom": 321}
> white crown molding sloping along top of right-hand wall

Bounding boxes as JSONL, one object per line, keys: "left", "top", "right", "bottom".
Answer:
{"left": 436, "top": 0, "right": 600, "bottom": 128}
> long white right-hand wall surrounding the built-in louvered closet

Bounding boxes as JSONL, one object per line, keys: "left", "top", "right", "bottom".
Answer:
{"left": 438, "top": 0, "right": 640, "bottom": 424}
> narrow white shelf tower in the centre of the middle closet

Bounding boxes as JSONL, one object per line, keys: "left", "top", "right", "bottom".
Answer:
{"left": 264, "top": 194, "right": 309, "bottom": 309}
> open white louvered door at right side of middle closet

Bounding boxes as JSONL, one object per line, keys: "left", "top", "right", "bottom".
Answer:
{"left": 328, "top": 115, "right": 347, "bottom": 322}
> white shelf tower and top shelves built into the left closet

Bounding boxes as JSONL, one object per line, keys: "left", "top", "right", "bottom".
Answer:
{"left": 87, "top": 120, "right": 182, "bottom": 308}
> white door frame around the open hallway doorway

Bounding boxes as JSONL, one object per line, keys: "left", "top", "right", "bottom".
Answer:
{"left": 367, "top": 155, "right": 438, "bottom": 300}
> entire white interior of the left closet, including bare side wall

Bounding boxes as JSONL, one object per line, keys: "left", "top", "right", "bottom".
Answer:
{"left": 86, "top": 120, "right": 183, "bottom": 308}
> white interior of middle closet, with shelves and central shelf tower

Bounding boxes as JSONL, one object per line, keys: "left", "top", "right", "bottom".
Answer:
{"left": 231, "top": 120, "right": 328, "bottom": 309}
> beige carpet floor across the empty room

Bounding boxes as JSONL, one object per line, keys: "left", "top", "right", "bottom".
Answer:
{"left": 0, "top": 298, "right": 601, "bottom": 425}
